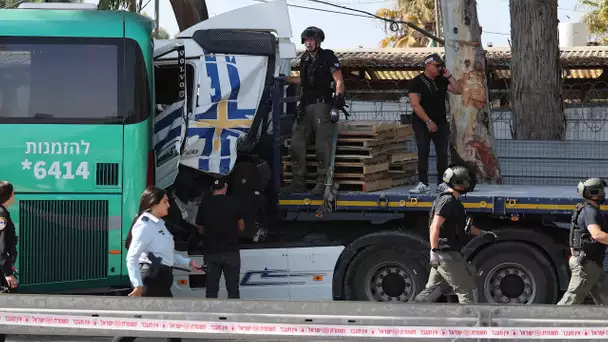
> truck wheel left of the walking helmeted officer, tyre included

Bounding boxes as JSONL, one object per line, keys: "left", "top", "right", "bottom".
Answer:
{"left": 346, "top": 247, "right": 428, "bottom": 303}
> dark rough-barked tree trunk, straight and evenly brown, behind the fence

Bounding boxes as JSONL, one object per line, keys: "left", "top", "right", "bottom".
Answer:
{"left": 509, "top": 0, "right": 566, "bottom": 140}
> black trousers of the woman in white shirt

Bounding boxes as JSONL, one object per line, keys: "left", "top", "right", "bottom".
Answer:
{"left": 112, "top": 265, "right": 182, "bottom": 342}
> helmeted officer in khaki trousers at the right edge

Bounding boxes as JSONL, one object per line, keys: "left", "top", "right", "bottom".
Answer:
{"left": 557, "top": 178, "right": 608, "bottom": 305}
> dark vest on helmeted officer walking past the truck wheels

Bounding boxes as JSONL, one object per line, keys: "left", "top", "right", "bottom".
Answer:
{"left": 429, "top": 192, "right": 466, "bottom": 251}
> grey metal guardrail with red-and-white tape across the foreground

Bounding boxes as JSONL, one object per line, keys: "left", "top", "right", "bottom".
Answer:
{"left": 0, "top": 295, "right": 608, "bottom": 341}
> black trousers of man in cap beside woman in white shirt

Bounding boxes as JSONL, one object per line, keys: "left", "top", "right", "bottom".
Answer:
{"left": 205, "top": 251, "right": 241, "bottom": 299}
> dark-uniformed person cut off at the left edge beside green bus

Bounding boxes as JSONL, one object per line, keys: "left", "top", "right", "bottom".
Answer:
{"left": 0, "top": 181, "right": 18, "bottom": 341}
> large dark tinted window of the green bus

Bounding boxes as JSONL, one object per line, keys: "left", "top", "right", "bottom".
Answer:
{"left": 0, "top": 37, "right": 150, "bottom": 124}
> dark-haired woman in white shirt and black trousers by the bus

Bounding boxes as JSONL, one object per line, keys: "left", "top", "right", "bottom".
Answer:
{"left": 114, "top": 186, "right": 201, "bottom": 342}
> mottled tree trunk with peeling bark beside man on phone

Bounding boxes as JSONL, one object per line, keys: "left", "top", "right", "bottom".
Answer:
{"left": 441, "top": 0, "right": 502, "bottom": 183}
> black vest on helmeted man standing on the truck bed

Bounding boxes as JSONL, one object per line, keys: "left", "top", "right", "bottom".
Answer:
{"left": 300, "top": 49, "right": 333, "bottom": 101}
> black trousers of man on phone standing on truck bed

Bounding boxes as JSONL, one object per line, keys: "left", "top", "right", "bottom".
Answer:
{"left": 412, "top": 119, "right": 450, "bottom": 185}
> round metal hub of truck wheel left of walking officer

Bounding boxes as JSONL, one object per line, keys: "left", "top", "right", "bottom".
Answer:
{"left": 365, "top": 265, "right": 414, "bottom": 302}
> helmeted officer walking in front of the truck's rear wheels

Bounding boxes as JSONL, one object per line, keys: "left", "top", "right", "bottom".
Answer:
{"left": 414, "top": 166, "right": 496, "bottom": 304}
